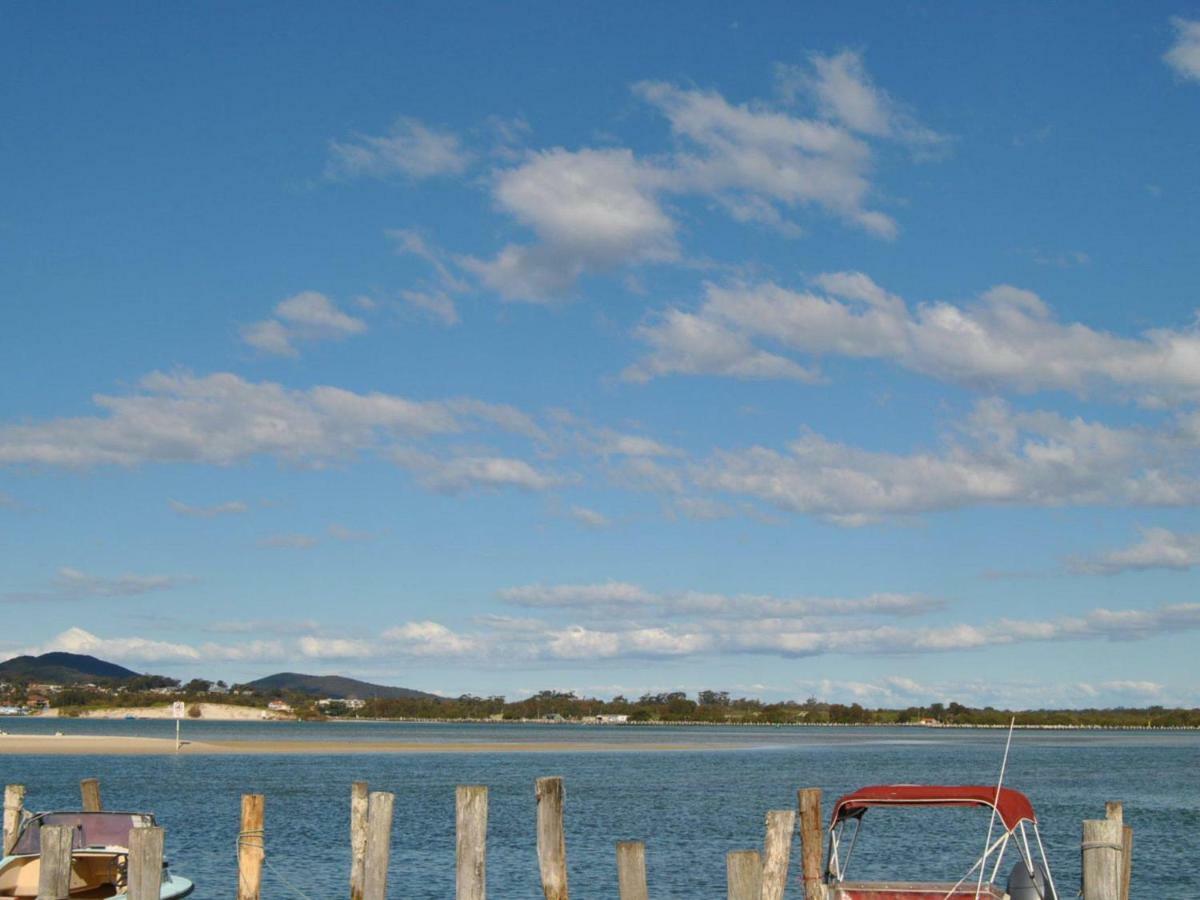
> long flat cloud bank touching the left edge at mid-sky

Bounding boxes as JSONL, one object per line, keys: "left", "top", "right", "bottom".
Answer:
{"left": 0, "top": 372, "right": 538, "bottom": 468}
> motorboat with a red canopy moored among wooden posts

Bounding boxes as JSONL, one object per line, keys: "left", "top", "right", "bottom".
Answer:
{"left": 824, "top": 785, "right": 1057, "bottom": 900}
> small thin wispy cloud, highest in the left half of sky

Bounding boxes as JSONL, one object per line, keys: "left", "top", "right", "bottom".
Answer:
{"left": 325, "top": 118, "right": 472, "bottom": 179}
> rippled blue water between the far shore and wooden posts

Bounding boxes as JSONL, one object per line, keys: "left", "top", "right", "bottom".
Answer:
{"left": 0, "top": 719, "right": 1200, "bottom": 900}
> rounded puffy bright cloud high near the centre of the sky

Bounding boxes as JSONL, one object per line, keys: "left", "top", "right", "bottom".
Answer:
{"left": 464, "top": 148, "right": 678, "bottom": 302}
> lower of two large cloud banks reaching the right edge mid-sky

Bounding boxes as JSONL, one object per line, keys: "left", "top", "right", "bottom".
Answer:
{"left": 691, "top": 400, "right": 1200, "bottom": 524}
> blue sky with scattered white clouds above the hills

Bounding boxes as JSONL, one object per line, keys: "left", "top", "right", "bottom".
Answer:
{"left": 0, "top": 2, "right": 1200, "bottom": 708}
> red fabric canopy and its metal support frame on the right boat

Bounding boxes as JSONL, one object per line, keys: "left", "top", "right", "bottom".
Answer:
{"left": 824, "top": 785, "right": 1058, "bottom": 900}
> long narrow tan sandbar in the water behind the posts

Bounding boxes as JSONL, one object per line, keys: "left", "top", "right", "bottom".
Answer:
{"left": 0, "top": 734, "right": 700, "bottom": 756}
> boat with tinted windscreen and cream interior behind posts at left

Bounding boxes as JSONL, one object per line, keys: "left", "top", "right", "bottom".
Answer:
{"left": 0, "top": 811, "right": 193, "bottom": 900}
